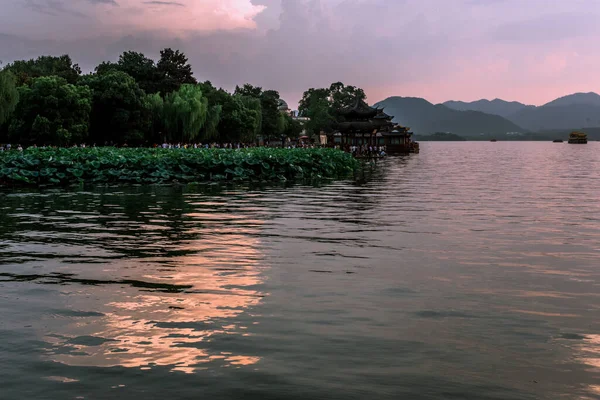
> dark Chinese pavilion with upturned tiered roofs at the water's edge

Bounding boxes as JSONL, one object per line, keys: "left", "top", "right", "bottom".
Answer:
{"left": 329, "top": 100, "right": 419, "bottom": 154}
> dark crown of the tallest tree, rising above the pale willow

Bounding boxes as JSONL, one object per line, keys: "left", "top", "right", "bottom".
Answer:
{"left": 156, "top": 48, "right": 198, "bottom": 96}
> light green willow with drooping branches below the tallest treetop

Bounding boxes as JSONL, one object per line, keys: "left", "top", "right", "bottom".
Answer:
{"left": 164, "top": 84, "right": 209, "bottom": 142}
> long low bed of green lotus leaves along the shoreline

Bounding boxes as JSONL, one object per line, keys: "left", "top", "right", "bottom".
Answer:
{"left": 0, "top": 147, "right": 358, "bottom": 185}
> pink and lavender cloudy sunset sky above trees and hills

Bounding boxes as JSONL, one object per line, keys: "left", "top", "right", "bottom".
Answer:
{"left": 0, "top": 0, "right": 600, "bottom": 108}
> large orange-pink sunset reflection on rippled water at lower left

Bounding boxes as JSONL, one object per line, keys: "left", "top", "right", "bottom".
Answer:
{"left": 41, "top": 211, "right": 267, "bottom": 373}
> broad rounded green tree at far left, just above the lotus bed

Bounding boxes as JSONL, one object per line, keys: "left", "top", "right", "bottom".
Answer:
{"left": 9, "top": 76, "right": 92, "bottom": 145}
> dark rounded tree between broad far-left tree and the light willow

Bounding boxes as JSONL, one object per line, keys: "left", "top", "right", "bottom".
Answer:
{"left": 80, "top": 70, "right": 152, "bottom": 144}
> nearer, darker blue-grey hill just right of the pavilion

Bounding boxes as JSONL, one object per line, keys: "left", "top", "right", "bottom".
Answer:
{"left": 375, "top": 97, "right": 523, "bottom": 137}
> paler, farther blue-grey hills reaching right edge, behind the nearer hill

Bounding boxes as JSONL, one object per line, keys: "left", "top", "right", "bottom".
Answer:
{"left": 444, "top": 92, "right": 600, "bottom": 131}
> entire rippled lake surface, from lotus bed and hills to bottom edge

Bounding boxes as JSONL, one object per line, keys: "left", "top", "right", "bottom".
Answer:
{"left": 0, "top": 142, "right": 600, "bottom": 400}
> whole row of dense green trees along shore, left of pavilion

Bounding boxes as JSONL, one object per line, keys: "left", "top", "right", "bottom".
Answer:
{"left": 0, "top": 48, "right": 342, "bottom": 145}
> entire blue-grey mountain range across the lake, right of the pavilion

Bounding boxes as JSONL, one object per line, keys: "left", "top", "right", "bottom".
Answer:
{"left": 375, "top": 93, "right": 600, "bottom": 139}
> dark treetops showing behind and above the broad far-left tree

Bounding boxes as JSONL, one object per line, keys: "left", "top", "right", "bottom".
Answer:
{"left": 6, "top": 55, "right": 81, "bottom": 86}
